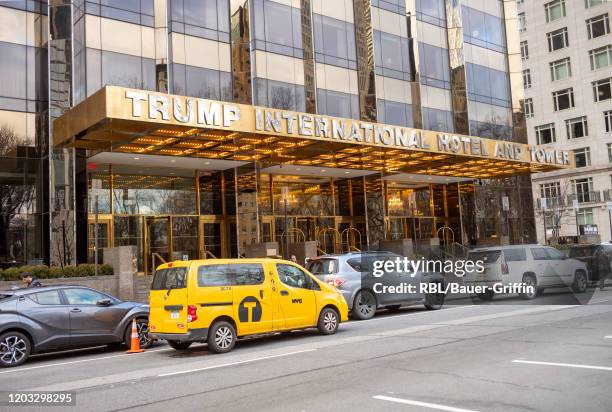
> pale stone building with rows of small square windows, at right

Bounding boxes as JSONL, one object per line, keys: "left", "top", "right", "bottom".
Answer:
{"left": 517, "top": 0, "right": 612, "bottom": 242}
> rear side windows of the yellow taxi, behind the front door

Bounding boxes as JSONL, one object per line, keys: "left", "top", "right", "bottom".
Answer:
{"left": 198, "top": 263, "right": 265, "bottom": 286}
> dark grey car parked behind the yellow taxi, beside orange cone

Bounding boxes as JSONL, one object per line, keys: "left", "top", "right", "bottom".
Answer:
{"left": 0, "top": 286, "right": 151, "bottom": 367}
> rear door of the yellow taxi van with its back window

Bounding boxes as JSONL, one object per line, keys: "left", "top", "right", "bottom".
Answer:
{"left": 149, "top": 265, "right": 189, "bottom": 333}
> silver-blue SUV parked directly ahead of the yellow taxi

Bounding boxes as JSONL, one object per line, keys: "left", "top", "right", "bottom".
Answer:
{"left": 306, "top": 252, "right": 444, "bottom": 320}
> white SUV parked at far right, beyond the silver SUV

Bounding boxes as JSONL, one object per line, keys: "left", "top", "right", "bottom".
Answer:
{"left": 464, "top": 245, "right": 588, "bottom": 300}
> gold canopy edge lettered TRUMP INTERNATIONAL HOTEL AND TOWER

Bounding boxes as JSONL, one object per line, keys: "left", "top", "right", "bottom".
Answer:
{"left": 54, "top": 86, "right": 573, "bottom": 172}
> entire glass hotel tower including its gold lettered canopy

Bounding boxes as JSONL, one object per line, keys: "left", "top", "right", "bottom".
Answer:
{"left": 0, "top": 0, "right": 568, "bottom": 272}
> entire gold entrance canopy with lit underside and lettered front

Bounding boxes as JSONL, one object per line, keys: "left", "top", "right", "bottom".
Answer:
{"left": 53, "top": 86, "right": 574, "bottom": 179}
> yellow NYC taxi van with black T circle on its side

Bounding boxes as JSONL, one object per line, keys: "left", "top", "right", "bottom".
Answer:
{"left": 149, "top": 258, "right": 348, "bottom": 353}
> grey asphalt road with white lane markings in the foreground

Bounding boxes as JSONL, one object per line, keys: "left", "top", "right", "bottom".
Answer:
{"left": 0, "top": 288, "right": 612, "bottom": 412}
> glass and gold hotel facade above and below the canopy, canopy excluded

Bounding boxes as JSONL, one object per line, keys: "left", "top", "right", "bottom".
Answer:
{"left": 0, "top": 0, "right": 533, "bottom": 272}
